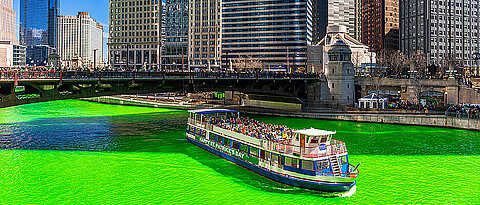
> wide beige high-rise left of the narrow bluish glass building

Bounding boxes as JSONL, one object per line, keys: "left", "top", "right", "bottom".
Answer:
{"left": 108, "top": 0, "right": 162, "bottom": 69}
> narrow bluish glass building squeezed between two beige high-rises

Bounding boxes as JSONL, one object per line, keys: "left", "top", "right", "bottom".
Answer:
{"left": 162, "top": 0, "right": 188, "bottom": 70}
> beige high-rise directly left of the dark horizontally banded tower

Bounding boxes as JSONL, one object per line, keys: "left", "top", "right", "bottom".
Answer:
{"left": 188, "top": 0, "right": 222, "bottom": 70}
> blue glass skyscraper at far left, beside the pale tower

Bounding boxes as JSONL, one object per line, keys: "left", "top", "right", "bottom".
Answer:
{"left": 19, "top": 0, "right": 59, "bottom": 47}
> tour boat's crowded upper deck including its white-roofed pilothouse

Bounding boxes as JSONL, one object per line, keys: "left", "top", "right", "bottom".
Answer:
{"left": 189, "top": 109, "right": 347, "bottom": 158}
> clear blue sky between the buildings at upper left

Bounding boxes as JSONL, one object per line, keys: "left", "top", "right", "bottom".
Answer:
{"left": 13, "top": 0, "right": 108, "bottom": 60}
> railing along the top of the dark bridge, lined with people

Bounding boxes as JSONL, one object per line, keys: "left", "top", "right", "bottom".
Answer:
{"left": 0, "top": 71, "right": 320, "bottom": 80}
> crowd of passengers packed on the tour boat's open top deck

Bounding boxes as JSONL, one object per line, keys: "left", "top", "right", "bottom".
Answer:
{"left": 207, "top": 116, "right": 293, "bottom": 142}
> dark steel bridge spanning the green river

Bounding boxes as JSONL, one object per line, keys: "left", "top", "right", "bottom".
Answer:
{"left": 0, "top": 71, "right": 321, "bottom": 107}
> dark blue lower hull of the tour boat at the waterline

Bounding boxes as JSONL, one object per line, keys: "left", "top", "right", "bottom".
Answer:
{"left": 187, "top": 137, "right": 355, "bottom": 192}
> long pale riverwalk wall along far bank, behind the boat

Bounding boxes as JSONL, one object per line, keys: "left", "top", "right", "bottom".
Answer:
{"left": 82, "top": 96, "right": 480, "bottom": 131}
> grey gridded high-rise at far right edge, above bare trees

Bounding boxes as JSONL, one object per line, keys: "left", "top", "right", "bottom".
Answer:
{"left": 400, "top": 0, "right": 480, "bottom": 69}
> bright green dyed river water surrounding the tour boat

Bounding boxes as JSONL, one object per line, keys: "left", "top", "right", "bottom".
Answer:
{"left": 0, "top": 100, "right": 480, "bottom": 204}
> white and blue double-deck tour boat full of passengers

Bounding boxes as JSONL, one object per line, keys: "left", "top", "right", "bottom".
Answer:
{"left": 186, "top": 109, "right": 359, "bottom": 192}
